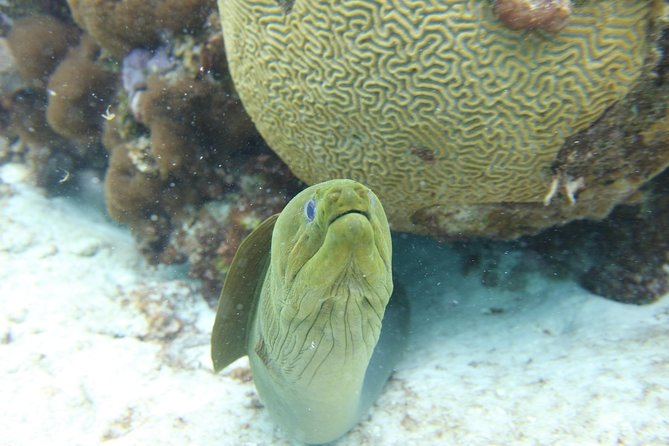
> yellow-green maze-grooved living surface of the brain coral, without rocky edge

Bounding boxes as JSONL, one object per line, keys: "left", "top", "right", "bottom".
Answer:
{"left": 219, "top": 0, "right": 653, "bottom": 237}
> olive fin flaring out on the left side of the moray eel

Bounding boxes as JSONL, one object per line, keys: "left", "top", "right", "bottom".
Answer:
{"left": 211, "top": 214, "right": 278, "bottom": 372}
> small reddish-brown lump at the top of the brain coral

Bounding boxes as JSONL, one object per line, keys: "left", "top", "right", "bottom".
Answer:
{"left": 495, "top": 0, "right": 571, "bottom": 32}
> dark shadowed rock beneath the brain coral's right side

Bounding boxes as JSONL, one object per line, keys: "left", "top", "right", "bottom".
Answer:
{"left": 453, "top": 172, "right": 669, "bottom": 305}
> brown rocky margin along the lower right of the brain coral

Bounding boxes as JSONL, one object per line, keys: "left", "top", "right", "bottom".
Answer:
{"left": 415, "top": 66, "right": 669, "bottom": 239}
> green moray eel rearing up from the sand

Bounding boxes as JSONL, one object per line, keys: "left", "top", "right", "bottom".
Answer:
{"left": 211, "top": 180, "right": 409, "bottom": 444}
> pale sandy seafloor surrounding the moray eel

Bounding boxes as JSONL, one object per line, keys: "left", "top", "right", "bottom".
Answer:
{"left": 0, "top": 165, "right": 669, "bottom": 446}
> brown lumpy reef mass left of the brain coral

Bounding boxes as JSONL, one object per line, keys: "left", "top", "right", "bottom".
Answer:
{"left": 0, "top": 0, "right": 298, "bottom": 302}
